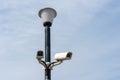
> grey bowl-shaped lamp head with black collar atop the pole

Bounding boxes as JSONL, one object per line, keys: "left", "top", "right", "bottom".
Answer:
{"left": 39, "top": 8, "right": 57, "bottom": 27}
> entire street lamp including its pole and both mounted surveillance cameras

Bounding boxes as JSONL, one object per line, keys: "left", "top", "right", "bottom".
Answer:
{"left": 36, "top": 8, "right": 72, "bottom": 80}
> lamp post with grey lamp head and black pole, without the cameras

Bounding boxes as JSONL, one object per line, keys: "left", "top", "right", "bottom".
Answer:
{"left": 39, "top": 8, "right": 57, "bottom": 80}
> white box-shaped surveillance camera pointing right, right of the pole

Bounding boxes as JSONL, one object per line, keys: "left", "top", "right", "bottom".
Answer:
{"left": 54, "top": 52, "right": 72, "bottom": 61}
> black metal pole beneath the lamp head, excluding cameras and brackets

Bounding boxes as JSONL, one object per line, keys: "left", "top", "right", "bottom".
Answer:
{"left": 45, "top": 26, "right": 51, "bottom": 80}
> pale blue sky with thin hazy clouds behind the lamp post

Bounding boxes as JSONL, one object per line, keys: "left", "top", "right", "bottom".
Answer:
{"left": 0, "top": 0, "right": 120, "bottom": 80}
